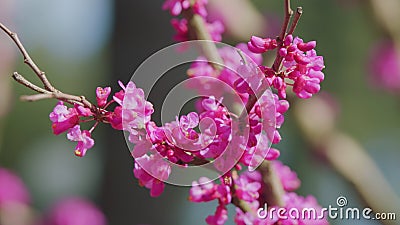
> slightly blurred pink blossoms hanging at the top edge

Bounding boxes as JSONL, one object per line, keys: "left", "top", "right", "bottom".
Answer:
{"left": 163, "top": 0, "right": 224, "bottom": 41}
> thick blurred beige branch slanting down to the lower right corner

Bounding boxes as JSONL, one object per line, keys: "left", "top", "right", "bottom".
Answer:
{"left": 293, "top": 96, "right": 400, "bottom": 225}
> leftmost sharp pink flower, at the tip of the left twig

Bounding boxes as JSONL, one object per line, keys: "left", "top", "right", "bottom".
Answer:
{"left": 50, "top": 101, "right": 79, "bottom": 135}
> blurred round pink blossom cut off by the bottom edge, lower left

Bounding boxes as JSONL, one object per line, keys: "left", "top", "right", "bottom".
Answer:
{"left": 44, "top": 197, "right": 106, "bottom": 225}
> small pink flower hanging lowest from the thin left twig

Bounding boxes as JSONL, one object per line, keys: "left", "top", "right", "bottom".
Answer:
{"left": 67, "top": 125, "right": 94, "bottom": 157}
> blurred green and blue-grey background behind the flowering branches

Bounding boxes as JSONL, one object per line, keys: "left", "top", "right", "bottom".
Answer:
{"left": 0, "top": 0, "right": 400, "bottom": 225}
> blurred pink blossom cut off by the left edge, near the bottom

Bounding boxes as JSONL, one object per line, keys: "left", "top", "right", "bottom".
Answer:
{"left": 0, "top": 168, "right": 30, "bottom": 208}
